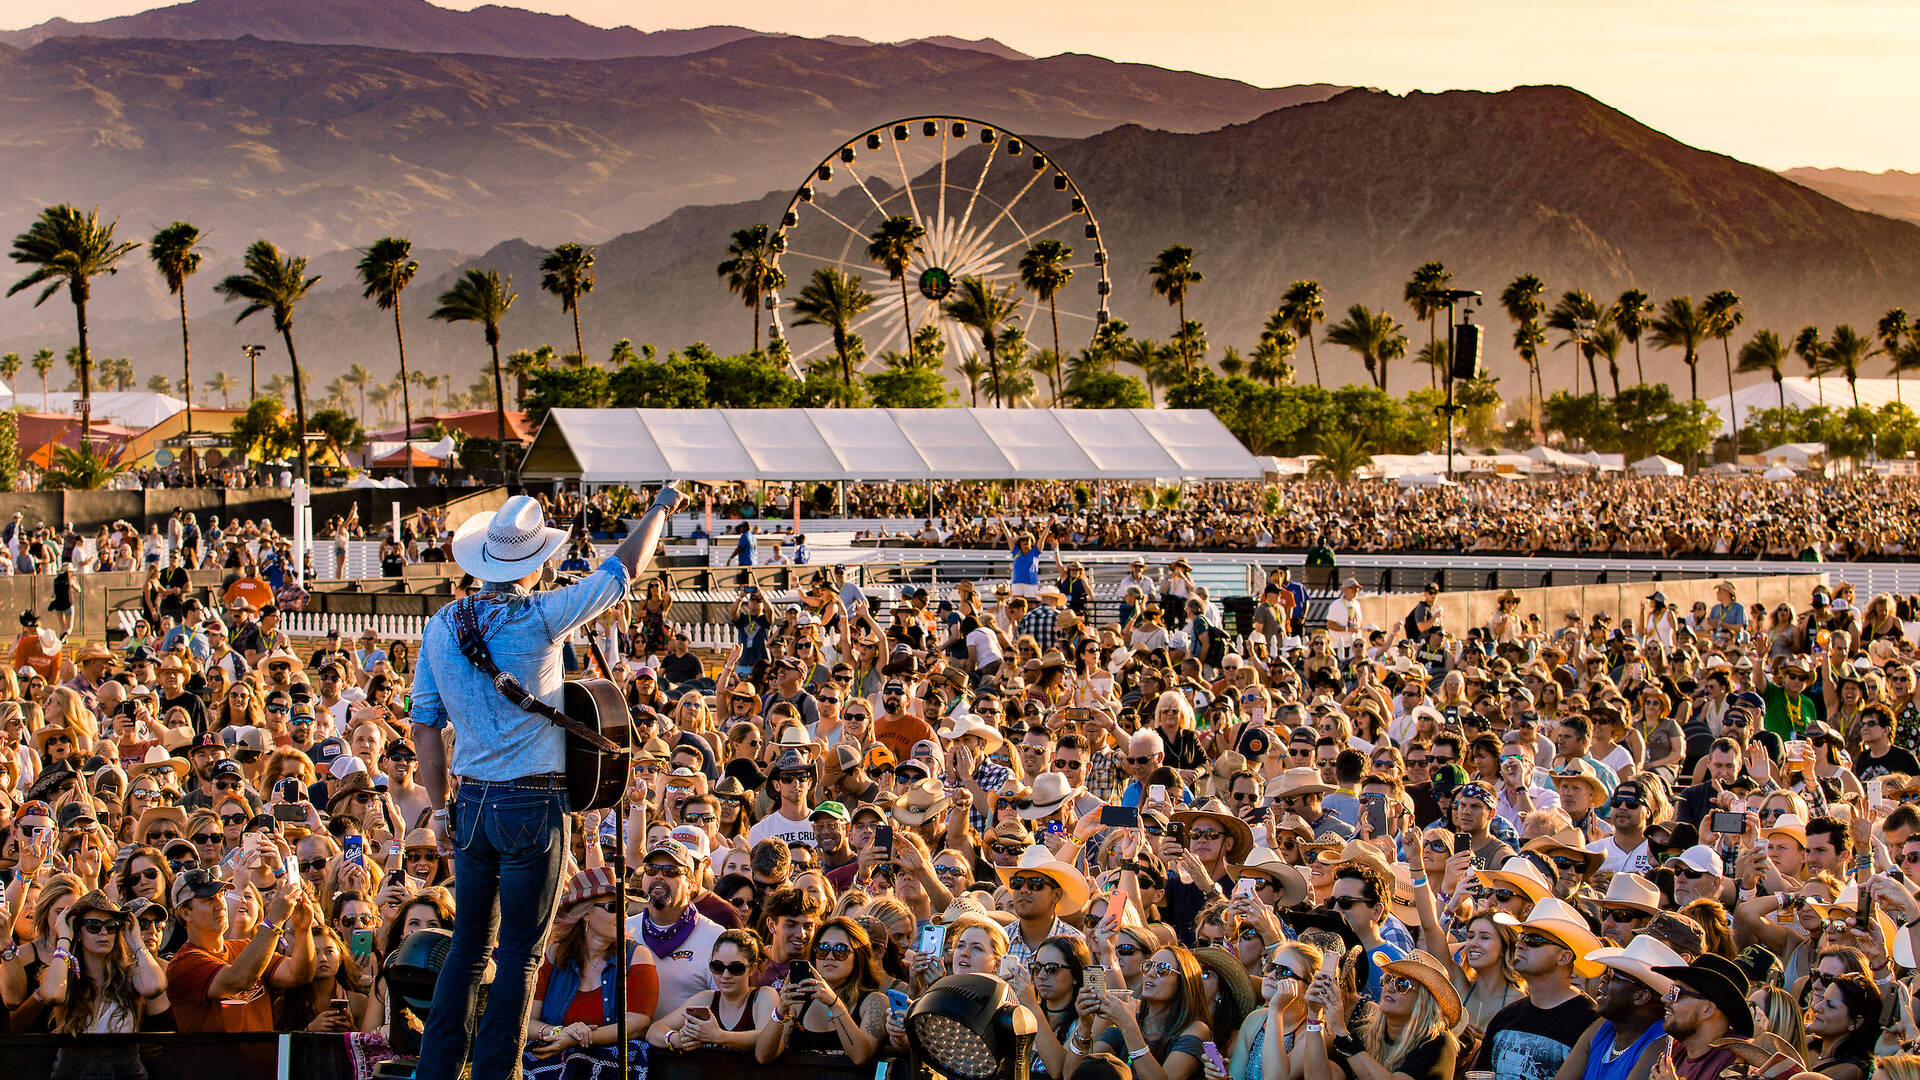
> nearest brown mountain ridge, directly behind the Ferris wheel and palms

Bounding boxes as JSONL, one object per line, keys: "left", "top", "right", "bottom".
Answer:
{"left": 26, "top": 86, "right": 1920, "bottom": 405}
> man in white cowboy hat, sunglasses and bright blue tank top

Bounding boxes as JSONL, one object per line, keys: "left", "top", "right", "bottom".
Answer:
{"left": 1561, "top": 936, "right": 1686, "bottom": 1080}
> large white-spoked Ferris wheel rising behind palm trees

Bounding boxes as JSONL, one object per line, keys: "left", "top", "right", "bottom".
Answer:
{"left": 766, "top": 115, "right": 1114, "bottom": 369}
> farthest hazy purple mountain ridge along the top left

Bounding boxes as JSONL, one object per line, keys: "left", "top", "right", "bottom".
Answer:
{"left": 0, "top": 0, "right": 1027, "bottom": 60}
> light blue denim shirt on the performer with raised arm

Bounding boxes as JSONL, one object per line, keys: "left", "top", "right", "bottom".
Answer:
{"left": 411, "top": 559, "right": 628, "bottom": 780}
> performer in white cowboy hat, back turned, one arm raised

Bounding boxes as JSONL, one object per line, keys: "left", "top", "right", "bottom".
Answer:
{"left": 413, "top": 484, "right": 680, "bottom": 1080}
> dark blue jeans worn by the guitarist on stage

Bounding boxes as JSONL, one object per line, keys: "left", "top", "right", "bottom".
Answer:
{"left": 419, "top": 780, "right": 568, "bottom": 1080}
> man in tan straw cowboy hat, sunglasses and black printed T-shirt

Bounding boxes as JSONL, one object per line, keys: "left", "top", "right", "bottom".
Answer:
{"left": 1473, "top": 897, "right": 1607, "bottom": 1080}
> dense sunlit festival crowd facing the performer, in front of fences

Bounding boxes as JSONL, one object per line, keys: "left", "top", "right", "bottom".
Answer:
{"left": 18, "top": 488, "right": 1920, "bottom": 1080}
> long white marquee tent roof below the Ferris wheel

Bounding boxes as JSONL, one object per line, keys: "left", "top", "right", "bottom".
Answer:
{"left": 520, "top": 409, "right": 1265, "bottom": 484}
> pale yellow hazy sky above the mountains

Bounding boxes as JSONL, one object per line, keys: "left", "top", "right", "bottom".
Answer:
{"left": 30, "top": 0, "right": 1920, "bottom": 171}
